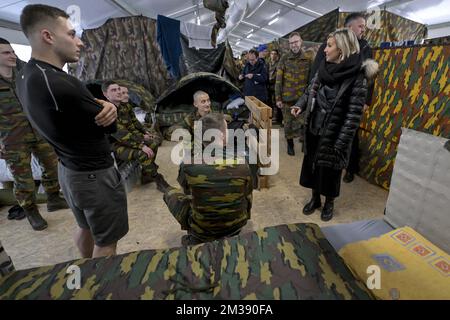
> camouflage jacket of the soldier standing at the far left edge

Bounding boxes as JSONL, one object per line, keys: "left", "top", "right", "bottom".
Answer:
{"left": 0, "top": 70, "right": 42, "bottom": 146}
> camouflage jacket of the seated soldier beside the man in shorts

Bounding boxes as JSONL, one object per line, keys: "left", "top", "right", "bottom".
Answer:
{"left": 111, "top": 103, "right": 146, "bottom": 149}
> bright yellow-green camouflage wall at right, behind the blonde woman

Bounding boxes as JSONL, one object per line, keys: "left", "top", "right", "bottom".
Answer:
{"left": 360, "top": 45, "right": 450, "bottom": 189}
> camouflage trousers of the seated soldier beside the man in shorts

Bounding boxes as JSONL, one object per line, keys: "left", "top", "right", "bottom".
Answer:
{"left": 113, "top": 145, "right": 158, "bottom": 176}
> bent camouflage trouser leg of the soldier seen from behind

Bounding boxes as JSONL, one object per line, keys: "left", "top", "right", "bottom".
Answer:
{"left": 164, "top": 188, "right": 192, "bottom": 230}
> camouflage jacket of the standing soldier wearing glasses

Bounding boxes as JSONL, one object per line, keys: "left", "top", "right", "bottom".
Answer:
{"left": 275, "top": 51, "right": 312, "bottom": 102}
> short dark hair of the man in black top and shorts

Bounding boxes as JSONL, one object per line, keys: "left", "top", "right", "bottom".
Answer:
{"left": 20, "top": 4, "right": 70, "bottom": 38}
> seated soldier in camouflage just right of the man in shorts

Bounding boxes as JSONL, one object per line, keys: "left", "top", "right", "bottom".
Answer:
{"left": 102, "top": 81, "right": 161, "bottom": 184}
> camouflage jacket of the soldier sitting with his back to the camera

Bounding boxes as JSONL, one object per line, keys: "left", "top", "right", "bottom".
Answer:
{"left": 178, "top": 156, "right": 253, "bottom": 241}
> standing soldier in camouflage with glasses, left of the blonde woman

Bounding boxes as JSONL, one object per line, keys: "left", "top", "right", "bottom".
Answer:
{"left": 275, "top": 32, "right": 312, "bottom": 156}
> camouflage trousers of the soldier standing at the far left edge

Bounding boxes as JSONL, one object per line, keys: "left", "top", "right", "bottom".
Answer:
{"left": 2, "top": 141, "right": 60, "bottom": 209}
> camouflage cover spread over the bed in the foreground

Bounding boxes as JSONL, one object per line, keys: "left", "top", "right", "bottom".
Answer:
{"left": 0, "top": 224, "right": 373, "bottom": 300}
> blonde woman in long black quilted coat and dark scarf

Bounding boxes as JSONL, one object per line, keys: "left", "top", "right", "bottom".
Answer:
{"left": 291, "top": 29, "right": 378, "bottom": 221}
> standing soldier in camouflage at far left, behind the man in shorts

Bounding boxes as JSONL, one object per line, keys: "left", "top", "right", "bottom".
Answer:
{"left": 0, "top": 38, "right": 68, "bottom": 230}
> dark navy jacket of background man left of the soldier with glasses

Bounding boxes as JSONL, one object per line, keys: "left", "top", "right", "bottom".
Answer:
{"left": 241, "top": 59, "right": 269, "bottom": 102}
